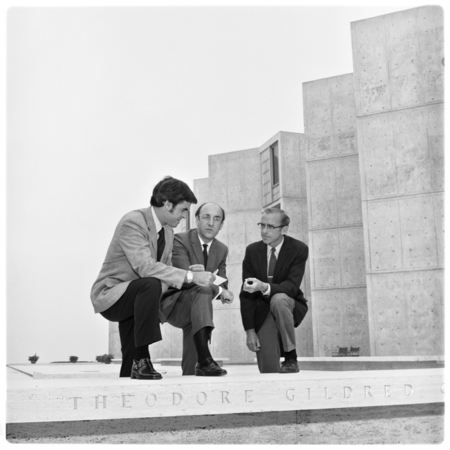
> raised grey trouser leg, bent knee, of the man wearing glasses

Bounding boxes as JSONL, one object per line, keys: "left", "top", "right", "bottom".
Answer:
{"left": 270, "top": 294, "right": 295, "bottom": 352}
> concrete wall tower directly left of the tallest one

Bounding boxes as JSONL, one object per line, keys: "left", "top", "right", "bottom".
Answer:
{"left": 303, "top": 74, "right": 370, "bottom": 356}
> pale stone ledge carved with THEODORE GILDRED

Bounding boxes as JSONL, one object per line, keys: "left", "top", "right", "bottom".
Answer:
{"left": 6, "top": 368, "right": 444, "bottom": 423}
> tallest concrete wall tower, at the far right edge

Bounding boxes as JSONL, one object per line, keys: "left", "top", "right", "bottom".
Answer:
{"left": 351, "top": 6, "right": 444, "bottom": 356}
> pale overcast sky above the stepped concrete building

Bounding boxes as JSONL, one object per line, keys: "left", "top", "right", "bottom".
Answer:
{"left": 5, "top": 2, "right": 432, "bottom": 363}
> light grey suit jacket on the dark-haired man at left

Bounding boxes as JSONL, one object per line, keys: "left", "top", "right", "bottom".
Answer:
{"left": 91, "top": 207, "right": 186, "bottom": 313}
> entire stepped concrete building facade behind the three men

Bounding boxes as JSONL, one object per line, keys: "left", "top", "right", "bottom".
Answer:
{"left": 110, "top": 6, "right": 444, "bottom": 363}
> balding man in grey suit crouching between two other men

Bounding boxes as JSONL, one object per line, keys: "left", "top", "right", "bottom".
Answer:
{"left": 161, "top": 203, "right": 234, "bottom": 376}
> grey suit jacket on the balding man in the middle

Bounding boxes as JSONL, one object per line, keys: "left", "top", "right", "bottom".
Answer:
{"left": 160, "top": 228, "right": 228, "bottom": 322}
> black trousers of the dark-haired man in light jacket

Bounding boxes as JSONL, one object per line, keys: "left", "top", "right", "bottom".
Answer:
{"left": 101, "top": 277, "right": 162, "bottom": 377}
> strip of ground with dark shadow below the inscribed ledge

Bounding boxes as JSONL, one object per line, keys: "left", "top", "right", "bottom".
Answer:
{"left": 6, "top": 403, "right": 444, "bottom": 444}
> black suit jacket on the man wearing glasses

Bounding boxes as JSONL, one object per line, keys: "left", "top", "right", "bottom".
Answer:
{"left": 239, "top": 235, "right": 308, "bottom": 332}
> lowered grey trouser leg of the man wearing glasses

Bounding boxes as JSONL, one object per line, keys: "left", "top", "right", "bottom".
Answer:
{"left": 256, "top": 312, "right": 281, "bottom": 373}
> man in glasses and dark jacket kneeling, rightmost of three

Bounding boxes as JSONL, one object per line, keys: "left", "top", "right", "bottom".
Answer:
{"left": 239, "top": 208, "right": 308, "bottom": 373}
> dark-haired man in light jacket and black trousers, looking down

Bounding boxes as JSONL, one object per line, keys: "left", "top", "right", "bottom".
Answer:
{"left": 91, "top": 177, "right": 215, "bottom": 380}
